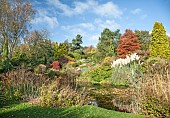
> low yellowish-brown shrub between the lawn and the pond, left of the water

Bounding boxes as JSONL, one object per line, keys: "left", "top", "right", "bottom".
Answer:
{"left": 40, "top": 81, "right": 88, "bottom": 107}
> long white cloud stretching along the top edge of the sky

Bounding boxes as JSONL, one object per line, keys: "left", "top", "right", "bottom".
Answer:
{"left": 47, "top": 0, "right": 123, "bottom": 18}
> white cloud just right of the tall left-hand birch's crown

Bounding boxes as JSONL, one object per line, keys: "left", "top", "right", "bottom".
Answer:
{"left": 32, "top": 9, "right": 59, "bottom": 29}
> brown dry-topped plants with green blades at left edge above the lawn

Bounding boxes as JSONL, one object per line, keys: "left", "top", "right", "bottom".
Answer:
{"left": 0, "top": 69, "right": 48, "bottom": 101}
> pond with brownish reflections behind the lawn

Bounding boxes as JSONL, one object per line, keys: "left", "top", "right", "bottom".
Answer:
{"left": 78, "top": 82, "right": 137, "bottom": 112}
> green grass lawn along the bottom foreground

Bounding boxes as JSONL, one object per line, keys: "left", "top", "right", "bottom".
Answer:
{"left": 0, "top": 103, "right": 143, "bottom": 118}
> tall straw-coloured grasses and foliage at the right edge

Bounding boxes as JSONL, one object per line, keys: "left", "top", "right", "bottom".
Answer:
{"left": 138, "top": 58, "right": 170, "bottom": 117}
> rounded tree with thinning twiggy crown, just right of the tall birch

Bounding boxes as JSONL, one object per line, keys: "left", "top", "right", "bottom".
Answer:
{"left": 24, "top": 30, "right": 54, "bottom": 65}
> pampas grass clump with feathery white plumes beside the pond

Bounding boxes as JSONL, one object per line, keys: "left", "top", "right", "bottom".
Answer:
{"left": 111, "top": 53, "right": 142, "bottom": 86}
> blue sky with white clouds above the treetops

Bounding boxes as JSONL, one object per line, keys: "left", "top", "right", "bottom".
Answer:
{"left": 31, "top": 0, "right": 170, "bottom": 46}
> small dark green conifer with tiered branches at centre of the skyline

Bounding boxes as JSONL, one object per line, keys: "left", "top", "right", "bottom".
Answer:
{"left": 71, "top": 34, "right": 83, "bottom": 53}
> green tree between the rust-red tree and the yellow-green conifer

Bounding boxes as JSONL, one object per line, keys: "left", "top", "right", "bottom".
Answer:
{"left": 135, "top": 30, "right": 151, "bottom": 51}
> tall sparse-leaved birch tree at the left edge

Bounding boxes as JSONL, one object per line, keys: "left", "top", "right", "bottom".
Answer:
{"left": 0, "top": 0, "right": 35, "bottom": 59}
